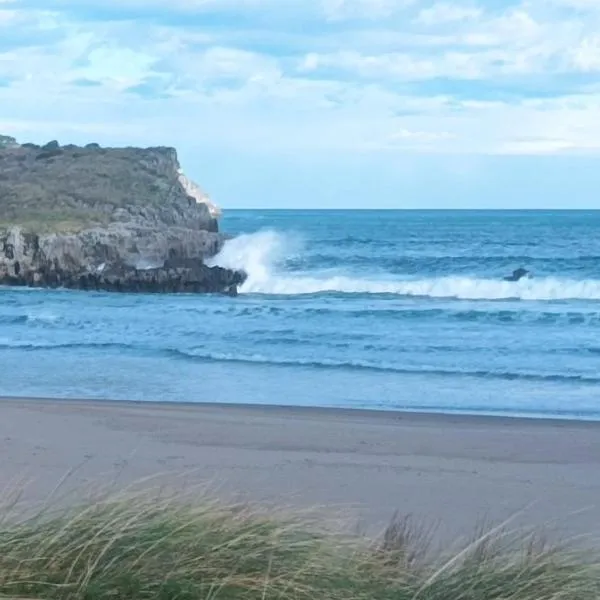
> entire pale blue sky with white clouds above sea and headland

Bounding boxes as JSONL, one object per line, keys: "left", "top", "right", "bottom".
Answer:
{"left": 0, "top": 0, "right": 600, "bottom": 209}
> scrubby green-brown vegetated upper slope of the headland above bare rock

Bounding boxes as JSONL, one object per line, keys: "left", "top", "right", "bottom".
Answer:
{"left": 0, "top": 136, "right": 216, "bottom": 234}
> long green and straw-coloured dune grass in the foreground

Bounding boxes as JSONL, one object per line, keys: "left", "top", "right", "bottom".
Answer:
{"left": 0, "top": 486, "right": 600, "bottom": 600}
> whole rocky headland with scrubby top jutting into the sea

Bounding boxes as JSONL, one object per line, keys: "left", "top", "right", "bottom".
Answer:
{"left": 0, "top": 136, "right": 245, "bottom": 294}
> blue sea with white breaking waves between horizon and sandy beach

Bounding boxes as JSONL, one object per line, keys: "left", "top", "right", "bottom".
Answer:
{"left": 0, "top": 211, "right": 600, "bottom": 419}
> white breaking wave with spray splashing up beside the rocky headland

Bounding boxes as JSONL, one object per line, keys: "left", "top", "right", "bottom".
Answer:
{"left": 207, "top": 231, "right": 600, "bottom": 300}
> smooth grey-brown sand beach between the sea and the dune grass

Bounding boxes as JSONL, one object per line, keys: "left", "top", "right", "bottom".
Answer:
{"left": 0, "top": 399, "right": 600, "bottom": 539}
